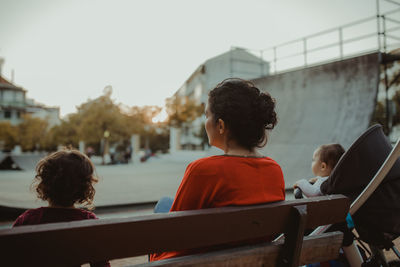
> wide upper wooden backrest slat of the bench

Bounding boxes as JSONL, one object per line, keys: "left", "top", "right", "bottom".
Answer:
{"left": 0, "top": 195, "right": 349, "bottom": 266}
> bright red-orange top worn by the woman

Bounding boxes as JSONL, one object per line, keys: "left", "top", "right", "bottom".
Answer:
{"left": 150, "top": 156, "right": 285, "bottom": 261}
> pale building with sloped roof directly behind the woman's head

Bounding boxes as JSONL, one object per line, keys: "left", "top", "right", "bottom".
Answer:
{"left": 170, "top": 48, "right": 270, "bottom": 151}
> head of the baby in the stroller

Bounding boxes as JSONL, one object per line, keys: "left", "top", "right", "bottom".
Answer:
{"left": 311, "top": 144, "right": 344, "bottom": 177}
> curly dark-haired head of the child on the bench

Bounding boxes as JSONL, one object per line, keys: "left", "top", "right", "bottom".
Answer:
{"left": 34, "top": 149, "right": 97, "bottom": 207}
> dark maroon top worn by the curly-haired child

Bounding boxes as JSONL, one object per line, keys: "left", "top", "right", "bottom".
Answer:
{"left": 13, "top": 207, "right": 110, "bottom": 267}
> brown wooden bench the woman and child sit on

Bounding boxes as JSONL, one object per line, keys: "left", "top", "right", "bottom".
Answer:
{"left": 0, "top": 195, "right": 349, "bottom": 266}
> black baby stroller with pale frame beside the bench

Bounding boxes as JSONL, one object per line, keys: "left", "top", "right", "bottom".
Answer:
{"left": 295, "top": 125, "right": 400, "bottom": 266}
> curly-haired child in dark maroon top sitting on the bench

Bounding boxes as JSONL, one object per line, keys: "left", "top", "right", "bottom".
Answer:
{"left": 13, "top": 149, "right": 110, "bottom": 266}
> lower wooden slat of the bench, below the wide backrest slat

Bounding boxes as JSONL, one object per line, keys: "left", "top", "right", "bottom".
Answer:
{"left": 136, "top": 232, "right": 343, "bottom": 267}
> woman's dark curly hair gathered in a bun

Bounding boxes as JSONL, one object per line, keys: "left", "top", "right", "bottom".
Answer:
{"left": 208, "top": 78, "right": 277, "bottom": 150}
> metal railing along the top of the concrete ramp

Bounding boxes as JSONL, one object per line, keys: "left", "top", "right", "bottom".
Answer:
{"left": 231, "top": 0, "right": 400, "bottom": 73}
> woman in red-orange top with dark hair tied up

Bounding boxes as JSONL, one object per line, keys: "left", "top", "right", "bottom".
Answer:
{"left": 150, "top": 79, "right": 285, "bottom": 261}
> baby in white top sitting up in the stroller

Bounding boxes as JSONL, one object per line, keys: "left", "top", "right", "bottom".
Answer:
{"left": 293, "top": 144, "right": 345, "bottom": 197}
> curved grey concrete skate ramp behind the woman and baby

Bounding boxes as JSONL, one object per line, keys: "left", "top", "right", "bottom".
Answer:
{"left": 254, "top": 53, "right": 379, "bottom": 188}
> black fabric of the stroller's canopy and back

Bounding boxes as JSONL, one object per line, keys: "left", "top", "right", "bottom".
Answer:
{"left": 321, "top": 125, "right": 400, "bottom": 246}
